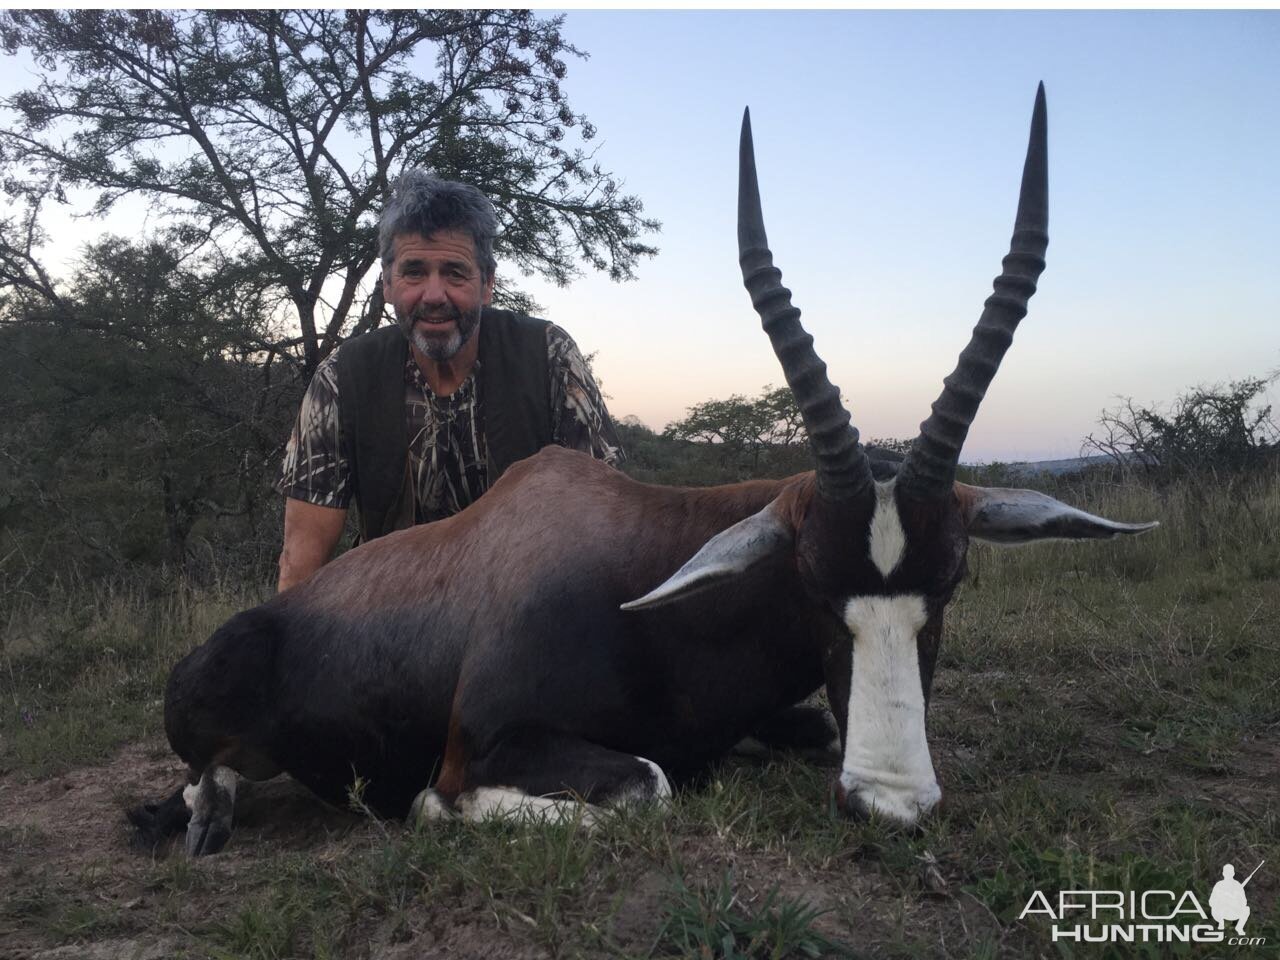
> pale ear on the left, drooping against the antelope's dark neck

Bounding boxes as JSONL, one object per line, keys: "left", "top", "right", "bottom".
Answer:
{"left": 622, "top": 500, "right": 795, "bottom": 611}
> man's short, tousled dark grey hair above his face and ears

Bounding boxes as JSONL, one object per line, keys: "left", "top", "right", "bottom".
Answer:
{"left": 378, "top": 169, "right": 498, "bottom": 280}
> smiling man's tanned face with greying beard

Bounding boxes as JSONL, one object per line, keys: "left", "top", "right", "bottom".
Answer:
{"left": 383, "top": 230, "right": 493, "bottom": 361}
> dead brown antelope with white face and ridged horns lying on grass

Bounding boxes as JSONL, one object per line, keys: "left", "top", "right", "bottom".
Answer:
{"left": 138, "top": 88, "right": 1153, "bottom": 854}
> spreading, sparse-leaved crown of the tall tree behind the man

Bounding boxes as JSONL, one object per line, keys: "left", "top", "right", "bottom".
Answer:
{"left": 0, "top": 10, "right": 658, "bottom": 379}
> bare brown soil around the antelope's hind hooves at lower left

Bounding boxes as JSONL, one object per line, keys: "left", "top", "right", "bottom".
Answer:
{"left": 0, "top": 741, "right": 372, "bottom": 960}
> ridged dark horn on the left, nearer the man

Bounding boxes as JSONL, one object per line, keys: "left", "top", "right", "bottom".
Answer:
{"left": 737, "top": 110, "right": 873, "bottom": 500}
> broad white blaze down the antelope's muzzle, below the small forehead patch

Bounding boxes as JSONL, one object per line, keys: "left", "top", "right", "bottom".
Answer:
{"left": 840, "top": 593, "right": 942, "bottom": 823}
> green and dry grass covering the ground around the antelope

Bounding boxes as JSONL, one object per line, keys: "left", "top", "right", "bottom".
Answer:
{"left": 0, "top": 465, "right": 1280, "bottom": 957}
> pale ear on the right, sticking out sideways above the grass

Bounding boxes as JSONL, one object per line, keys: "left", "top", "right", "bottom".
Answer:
{"left": 955, "top": 483, "right": 1160, "bottom": 544}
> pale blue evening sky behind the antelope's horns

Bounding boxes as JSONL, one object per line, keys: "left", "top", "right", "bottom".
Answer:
{"left": 0, "top": 10, "right": 1280, "bottom": 462}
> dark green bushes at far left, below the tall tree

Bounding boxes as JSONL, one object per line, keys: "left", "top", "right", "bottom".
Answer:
{"left": 0, "top": 237, "right": 301, "bottom": 591}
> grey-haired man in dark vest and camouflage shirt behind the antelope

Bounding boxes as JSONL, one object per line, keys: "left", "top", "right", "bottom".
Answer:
{"left": 276, "top": 170, "right": 622, "bottom": 590}
